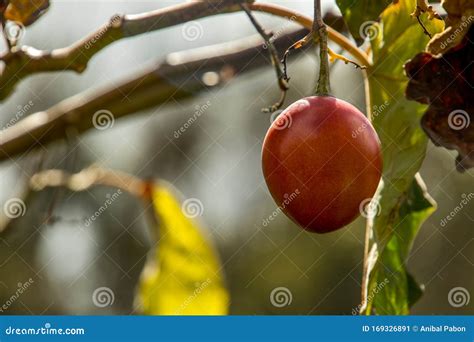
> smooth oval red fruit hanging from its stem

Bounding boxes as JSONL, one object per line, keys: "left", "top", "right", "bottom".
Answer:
{"left": 262, "top": 96, "right": 382, "bottom": 233}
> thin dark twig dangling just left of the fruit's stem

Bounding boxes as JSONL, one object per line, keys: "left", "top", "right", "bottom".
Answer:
{"left": 240, "top": 4, "right": 289, "bottom": 113}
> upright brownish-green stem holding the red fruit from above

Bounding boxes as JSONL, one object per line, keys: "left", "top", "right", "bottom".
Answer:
{"left": 313, "top": 0, "right": 330, "bottom": 96}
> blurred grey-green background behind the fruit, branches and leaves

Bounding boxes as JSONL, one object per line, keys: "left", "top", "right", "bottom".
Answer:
{"left": 0, "top": 0, "right": 474, "bottom": 315}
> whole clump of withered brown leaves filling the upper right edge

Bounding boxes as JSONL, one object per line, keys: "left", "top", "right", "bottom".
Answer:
{"left": 405, "top": 0, "right": 474, "bottom": 172}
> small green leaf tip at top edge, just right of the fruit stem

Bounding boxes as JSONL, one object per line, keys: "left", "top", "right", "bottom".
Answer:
{"left": 336, "top": 0, "right": 392, "bottom": 41}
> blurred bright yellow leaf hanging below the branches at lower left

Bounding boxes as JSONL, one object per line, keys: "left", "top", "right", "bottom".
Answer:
{"left": 137, "top": 182, "right": 229, "bottom": 315}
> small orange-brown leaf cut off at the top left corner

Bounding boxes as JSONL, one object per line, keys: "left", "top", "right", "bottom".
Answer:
{"left": 4, "top": 0, "right": 49, "bottom": 26}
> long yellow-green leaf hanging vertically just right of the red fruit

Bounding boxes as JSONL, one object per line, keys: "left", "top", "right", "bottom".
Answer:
{"left": 365, "top": 0, "right": 442, "bottom": 314}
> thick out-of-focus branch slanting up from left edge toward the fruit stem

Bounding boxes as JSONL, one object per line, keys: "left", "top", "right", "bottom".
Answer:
{"left": 0, "top": 30, "right": 307, "bottom": 160}
